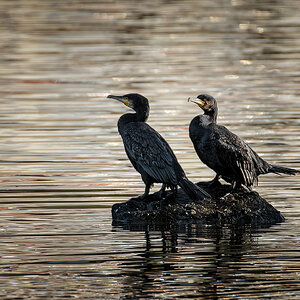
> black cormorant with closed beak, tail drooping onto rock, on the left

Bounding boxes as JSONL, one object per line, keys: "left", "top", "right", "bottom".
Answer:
{"left": 107, "top": 94, "right": 210, "bottom": 200}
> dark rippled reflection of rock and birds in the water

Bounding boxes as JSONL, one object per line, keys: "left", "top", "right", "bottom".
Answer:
{"left": 120, "top": 225, "right": 256, "bottom": 299}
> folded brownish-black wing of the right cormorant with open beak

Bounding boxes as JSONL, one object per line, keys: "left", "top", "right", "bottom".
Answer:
{"left": 215, "top": 126, "right": 257, "bottom": 186}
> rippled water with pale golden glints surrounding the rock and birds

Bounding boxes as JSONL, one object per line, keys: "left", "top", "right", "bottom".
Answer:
{"left": 0, "top": 0, "right": 300, "bottom": 299}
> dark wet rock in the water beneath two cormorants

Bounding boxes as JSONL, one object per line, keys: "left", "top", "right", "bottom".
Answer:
{"left": 112, "top": 182, "right": 285, "bottom": 227}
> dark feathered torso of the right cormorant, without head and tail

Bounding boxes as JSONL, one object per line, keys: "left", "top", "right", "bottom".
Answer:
{"left": 190, "top": 116, "right": 268, "bottom": 186}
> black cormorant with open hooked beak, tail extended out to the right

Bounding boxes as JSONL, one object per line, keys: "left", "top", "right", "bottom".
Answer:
{"left": 189, "top": 94, "right": 299, "bottom": 190}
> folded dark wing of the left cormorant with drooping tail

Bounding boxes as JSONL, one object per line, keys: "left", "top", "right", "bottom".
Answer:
{"left": 122, "top": 123, "right": 180, "bottom": 184}
